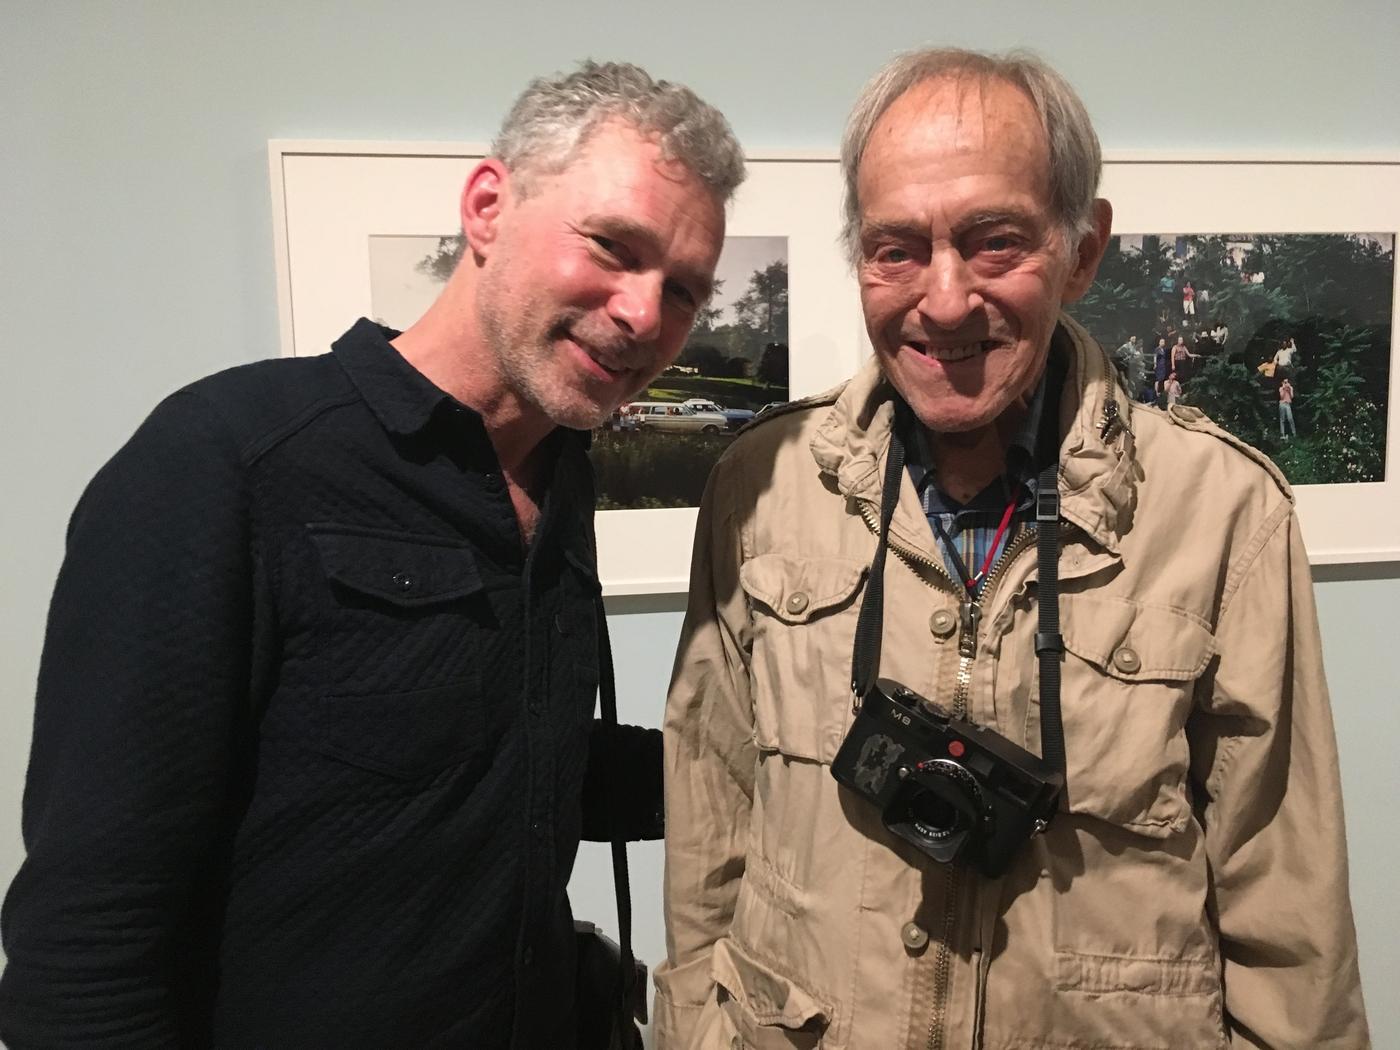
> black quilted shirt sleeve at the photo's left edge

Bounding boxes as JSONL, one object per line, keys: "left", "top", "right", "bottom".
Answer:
{"left": 0, "top": 393, "right": 251, "bottom": 1050}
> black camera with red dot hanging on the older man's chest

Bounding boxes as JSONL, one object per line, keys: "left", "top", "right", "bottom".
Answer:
{"left": 832, "top": 678, "right": 1064, "bottom": 878}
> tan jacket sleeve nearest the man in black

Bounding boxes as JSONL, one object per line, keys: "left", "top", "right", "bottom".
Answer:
{"left": 655, "top": 459, "right": 757, "bottom": 1050}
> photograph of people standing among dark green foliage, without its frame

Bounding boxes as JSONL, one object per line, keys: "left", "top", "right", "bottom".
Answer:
{"left": 1070, "top": 234, "right": 1394, "bottom": 484}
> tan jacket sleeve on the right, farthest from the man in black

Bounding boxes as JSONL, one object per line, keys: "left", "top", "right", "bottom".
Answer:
{"left": 1190, "top": 503, "right": 1369, "bottom": 1050}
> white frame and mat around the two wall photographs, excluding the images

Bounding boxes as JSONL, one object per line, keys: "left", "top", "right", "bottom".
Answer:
{"left": 269, "top": 140, "right": 1400, "bottom": 585}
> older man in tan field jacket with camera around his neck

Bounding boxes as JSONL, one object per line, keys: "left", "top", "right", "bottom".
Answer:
{"left": 657, "top": 50, "right": 1366, "bottom": 1050}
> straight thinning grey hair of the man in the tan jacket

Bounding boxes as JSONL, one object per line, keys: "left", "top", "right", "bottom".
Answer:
{"left": 841, "top": 48, "right": 1103, "bottom": 265}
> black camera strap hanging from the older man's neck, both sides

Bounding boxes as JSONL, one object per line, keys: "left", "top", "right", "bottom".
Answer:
{"left": 851, "top": 398, "right": 1065, "bottom": 773}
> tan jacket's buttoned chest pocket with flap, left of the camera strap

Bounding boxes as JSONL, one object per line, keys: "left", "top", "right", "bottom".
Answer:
{"left": 739, "top": 554, "right": 867, "bottom": 763}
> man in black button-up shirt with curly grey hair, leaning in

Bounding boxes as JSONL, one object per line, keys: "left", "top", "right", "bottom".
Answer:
{"left": 0, "top": 63, "right": 743, "bottom": 1050}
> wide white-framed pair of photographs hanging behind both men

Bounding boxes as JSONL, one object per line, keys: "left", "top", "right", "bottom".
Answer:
{"left": 269, "top": 141, "right": 1400, "bottom": 576}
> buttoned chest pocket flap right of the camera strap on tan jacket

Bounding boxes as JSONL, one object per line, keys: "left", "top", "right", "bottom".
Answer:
{"left": 1060, "top": 595, "right": 1215, "bottom": 682}
